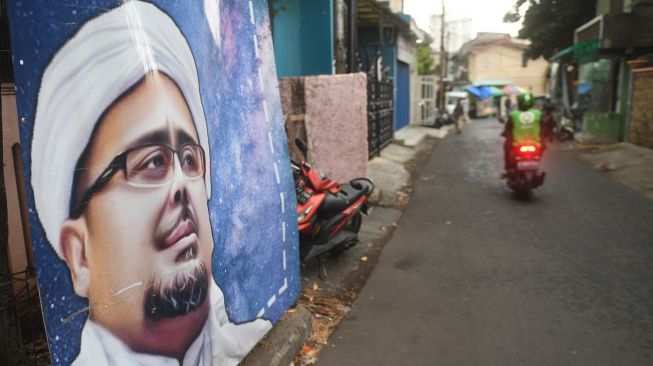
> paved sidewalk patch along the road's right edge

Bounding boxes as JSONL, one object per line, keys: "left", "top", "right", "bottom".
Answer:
{"left": 562, "top": 142, "right": 653, "bottom": 199}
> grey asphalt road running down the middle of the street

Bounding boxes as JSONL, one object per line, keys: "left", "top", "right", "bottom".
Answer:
{"left": 318, "top": 120, "right": 653, "bottom": 366}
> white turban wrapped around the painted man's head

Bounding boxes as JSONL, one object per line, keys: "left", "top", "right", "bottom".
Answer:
{"left": 31, "top": 1, "right": 211, "bottom": 258}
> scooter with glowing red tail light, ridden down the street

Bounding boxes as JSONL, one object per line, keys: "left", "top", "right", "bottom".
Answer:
{"left": 506, "top": 142, "right": 546, "bottom": 198}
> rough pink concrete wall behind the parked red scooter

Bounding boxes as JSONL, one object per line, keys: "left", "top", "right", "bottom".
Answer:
{"left": 279, "top": 73, "right": 368, "bottom": 182}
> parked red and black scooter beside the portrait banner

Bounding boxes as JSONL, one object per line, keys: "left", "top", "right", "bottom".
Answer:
{"left": 291, "top": 139, "right": 374, "bottom": 270}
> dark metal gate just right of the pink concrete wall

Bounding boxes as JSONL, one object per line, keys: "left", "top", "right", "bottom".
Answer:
{"left": 367, "top": 54, "right": 394, "bottom": 157}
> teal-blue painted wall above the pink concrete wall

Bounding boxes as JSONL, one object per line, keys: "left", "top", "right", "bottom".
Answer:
{"left": 273, "top": 0, "right": 334, "bottom": 77}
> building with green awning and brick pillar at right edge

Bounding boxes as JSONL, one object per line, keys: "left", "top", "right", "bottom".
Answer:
{"left": 551, "top": 0, "right": 653, "bottom": 147}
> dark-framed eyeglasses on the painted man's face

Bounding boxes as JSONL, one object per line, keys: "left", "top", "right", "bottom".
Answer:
{"left": 70, "top": 143, "right": 205, "bottom": 219}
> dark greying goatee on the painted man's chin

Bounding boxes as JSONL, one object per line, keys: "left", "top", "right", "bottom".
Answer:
{"left": 144, "top": 262, "right": 209, "bottom": 322}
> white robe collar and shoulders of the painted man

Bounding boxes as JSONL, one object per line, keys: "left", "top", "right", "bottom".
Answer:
{"left": 73, "top": 280, "right": 272, "bottom": 366}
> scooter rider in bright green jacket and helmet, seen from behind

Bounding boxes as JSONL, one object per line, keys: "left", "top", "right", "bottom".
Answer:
{"left": 501, "top": 93, "right": 544, "bottom": 172}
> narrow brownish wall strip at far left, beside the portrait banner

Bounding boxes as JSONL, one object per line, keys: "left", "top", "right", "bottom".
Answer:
{"left": 2, "top": 84, "right": 28, "bottom": 272}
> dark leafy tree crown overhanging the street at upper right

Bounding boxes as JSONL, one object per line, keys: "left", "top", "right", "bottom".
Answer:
{"left": 503, "top": 0, "right": 596, "bottom": 59}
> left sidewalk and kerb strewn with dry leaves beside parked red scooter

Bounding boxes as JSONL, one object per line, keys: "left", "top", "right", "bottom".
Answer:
{"left": 242, "top": 126, "right": 449, "bottom": 366}
